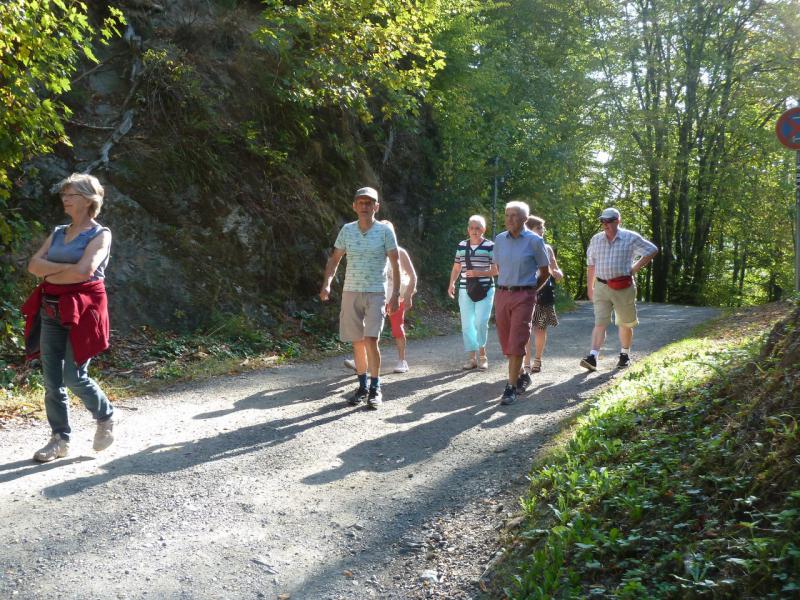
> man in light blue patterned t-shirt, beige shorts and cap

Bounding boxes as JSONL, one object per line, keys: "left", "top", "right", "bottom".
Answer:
{"left": 319, "top": 187, "right": 401, "bottom": 409}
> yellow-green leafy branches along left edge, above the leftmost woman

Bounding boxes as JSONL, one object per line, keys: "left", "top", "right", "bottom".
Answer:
{"left": 0, "top": 0, "right": 123, "bottom": 354}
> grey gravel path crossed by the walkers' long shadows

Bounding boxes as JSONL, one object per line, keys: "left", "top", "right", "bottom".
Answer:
{"left": 0, "top": 304, "right": 715, "bottom": 599}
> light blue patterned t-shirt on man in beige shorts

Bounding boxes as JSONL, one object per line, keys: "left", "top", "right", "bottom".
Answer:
{"left": 333, "top": 221, "right": 397, "bottom": 292}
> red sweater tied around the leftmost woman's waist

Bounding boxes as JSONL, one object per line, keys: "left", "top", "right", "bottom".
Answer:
{"left": 22, "top": 279, "right": 110, "bottom": 365}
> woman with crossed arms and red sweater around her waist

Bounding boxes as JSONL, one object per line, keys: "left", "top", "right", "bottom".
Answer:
{"left": 23, "top": 173, "right": 114, "bottom": 462}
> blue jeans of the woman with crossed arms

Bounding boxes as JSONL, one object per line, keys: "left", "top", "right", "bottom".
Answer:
{"left": 40, "top": 311, "right": 114, "bottom": 440}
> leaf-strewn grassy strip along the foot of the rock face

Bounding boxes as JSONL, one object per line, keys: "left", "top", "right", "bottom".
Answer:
{"left": 0, "top": 300, "right": 457, "bottom": 426}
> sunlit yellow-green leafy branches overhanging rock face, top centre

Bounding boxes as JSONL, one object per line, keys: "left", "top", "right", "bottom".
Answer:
{"left": 259, "top": 0, "right": 471, "bottom": 123}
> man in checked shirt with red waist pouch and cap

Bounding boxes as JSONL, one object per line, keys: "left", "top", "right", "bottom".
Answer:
{"left": 581, "top": 208, "right": 658, "bottom": 371}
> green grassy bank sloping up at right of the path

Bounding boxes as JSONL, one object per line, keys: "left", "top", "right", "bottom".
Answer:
{"left": 493, "top": 305, "right": 800, "bottom": 599}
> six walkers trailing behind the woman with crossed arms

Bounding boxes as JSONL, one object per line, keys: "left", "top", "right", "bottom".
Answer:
{"left": 319, "top": 187, "right": 658, "bottom": 409}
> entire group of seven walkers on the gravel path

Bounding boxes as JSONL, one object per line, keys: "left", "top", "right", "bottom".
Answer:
{"left": 22, "top": 173, "right": 658, "bottom": 462}
